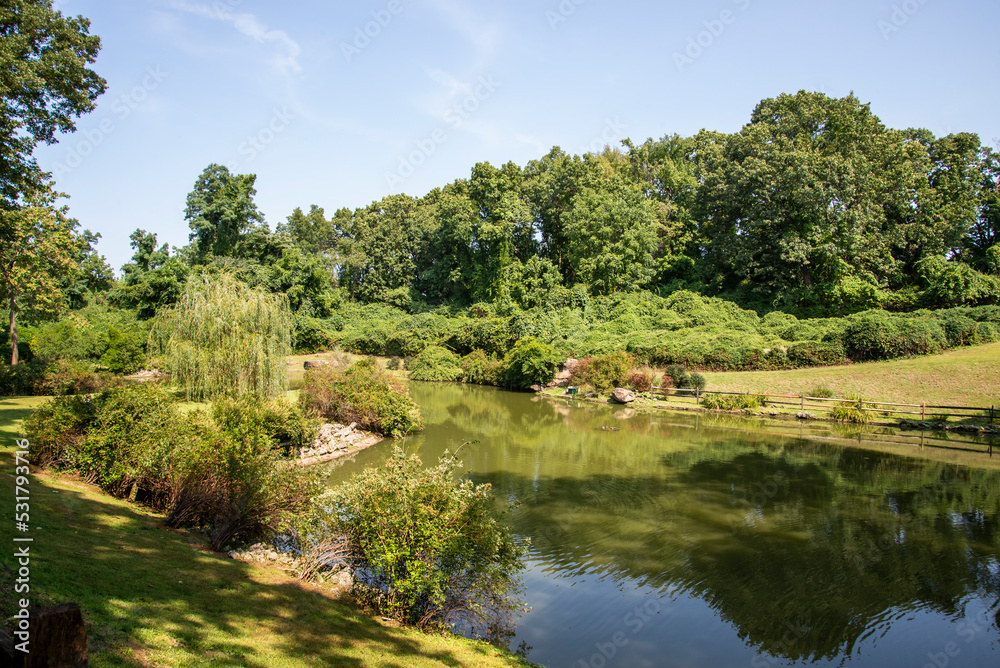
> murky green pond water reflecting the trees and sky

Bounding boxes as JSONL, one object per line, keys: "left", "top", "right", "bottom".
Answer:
{"left": 322, "top": 383, "right": 1000, "bottom": 668}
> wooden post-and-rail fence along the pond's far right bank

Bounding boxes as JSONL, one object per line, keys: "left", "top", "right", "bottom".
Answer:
{"left": 651, "top": 386, "right": 1000, "bottom": 424}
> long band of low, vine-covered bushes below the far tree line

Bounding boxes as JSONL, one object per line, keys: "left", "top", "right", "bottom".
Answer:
{"left": 320, "top": 291, "right": 1000, "bottom": 375}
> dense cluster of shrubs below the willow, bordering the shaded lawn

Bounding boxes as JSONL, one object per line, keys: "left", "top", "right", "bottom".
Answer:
{"left": 25, "top": 384, "right": 318, "bottom": 550}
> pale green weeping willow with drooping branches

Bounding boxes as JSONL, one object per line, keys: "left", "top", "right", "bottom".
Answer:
{"left": 150, "top": 275, "right": 292, "bottom": 400}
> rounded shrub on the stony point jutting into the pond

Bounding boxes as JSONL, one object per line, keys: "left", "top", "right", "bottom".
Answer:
{"left": 299, "top": 359, "right": 421, "bottom": 438}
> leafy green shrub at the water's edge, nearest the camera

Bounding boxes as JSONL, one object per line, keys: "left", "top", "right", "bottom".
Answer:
{"left": 298, "top": 448, "right": 524, "bottom": 636}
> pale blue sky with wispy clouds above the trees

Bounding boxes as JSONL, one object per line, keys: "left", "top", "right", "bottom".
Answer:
{"left": 36, "top": 0, "right": 1000, "bottom": 270}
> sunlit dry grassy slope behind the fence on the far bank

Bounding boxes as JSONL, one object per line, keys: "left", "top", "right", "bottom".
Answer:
{"left": 704, "top": 343, "right": 1000, "bottom": 407}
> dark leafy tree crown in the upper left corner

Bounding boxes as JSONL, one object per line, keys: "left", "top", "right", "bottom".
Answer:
{"left": 0, "top": 0, "right": 105, "bottom": 209}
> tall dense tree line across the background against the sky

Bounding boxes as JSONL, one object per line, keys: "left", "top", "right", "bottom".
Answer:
{"left": 115, "top": 91, "right": 1000, "bottom": 328}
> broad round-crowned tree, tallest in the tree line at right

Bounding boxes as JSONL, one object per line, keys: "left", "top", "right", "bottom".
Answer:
{"left": 698, "top": 91, "right": 930, "bottom": 305}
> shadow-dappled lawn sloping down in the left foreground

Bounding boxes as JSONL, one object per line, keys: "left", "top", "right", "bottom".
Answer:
{"left": 0, "top": 398, "right": 536, "bottom": 668}
